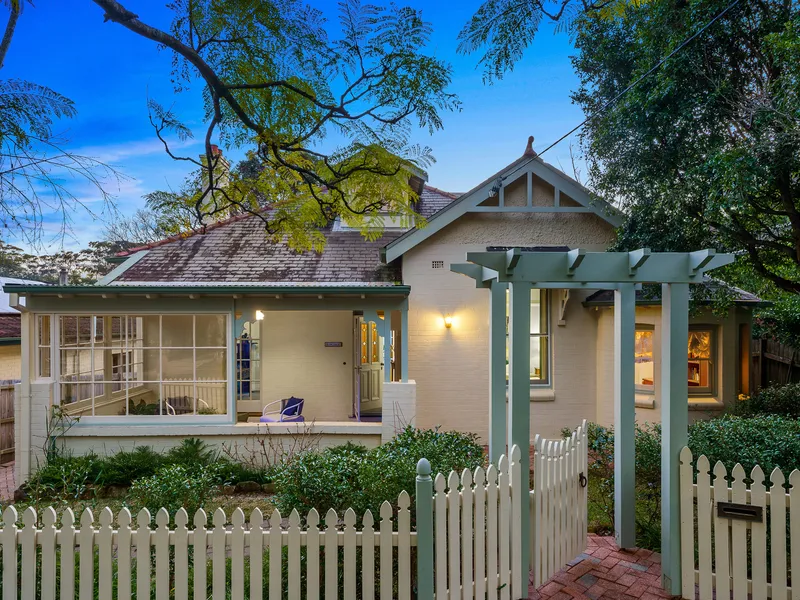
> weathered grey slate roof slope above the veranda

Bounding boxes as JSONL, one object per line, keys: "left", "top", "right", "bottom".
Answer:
{"left": 113, "top": 216, "right": 401, "bottom": 285}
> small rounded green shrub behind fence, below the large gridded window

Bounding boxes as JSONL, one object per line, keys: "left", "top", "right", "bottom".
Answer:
{"left": 130, "top": 465, "right": 219, "bottom": 520}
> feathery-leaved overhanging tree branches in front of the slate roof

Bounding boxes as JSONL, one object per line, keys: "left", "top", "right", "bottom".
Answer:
{"left": 93, "top": 0, "right": 459, "bottom": 248}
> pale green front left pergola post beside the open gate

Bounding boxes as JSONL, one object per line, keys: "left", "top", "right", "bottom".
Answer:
{"left": 508, "top": 281, "right": 531, "bottom": 565}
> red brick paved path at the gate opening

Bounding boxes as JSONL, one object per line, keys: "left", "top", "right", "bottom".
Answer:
{"left": 528, "top": 534, "right": 672, "bottom": 600}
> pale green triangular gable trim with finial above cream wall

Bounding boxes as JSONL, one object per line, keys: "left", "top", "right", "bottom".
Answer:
{"left": 385, "top": 154, "right": 622, "bottom": 262}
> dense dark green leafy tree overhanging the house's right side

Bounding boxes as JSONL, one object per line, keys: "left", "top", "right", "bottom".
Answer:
{"left": 573, "top": 0, "right": 800, "bottom": 293}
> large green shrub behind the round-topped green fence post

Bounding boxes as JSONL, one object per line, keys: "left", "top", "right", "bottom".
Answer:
{"left": 359, "top": 426, "right": 486, "bottom": 515}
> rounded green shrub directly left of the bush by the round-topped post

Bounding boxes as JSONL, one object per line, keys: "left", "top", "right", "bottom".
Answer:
{"left": 275, "top": 442, "right": 368, "bottom": 519}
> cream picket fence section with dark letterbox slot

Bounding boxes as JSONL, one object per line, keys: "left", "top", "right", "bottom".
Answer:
{"left": 680, "top": 448, "right": 800, "bottom": 600}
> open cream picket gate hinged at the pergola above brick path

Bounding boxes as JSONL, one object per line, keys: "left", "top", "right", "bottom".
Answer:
{"left": 530, "top": 420, "right": 589, "bottom": 587}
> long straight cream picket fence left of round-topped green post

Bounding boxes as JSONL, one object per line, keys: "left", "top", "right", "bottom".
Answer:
{"left": 0, "top": 492, "right": 416, "bottom": 600}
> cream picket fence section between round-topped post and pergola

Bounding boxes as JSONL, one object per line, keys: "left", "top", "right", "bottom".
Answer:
{"left": 433, "top": 446, "right": 527, "bottom": 600}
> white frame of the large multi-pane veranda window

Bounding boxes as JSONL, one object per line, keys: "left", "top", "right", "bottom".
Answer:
{"left": 53, "top": 310, "right": 236, "bottom": 425}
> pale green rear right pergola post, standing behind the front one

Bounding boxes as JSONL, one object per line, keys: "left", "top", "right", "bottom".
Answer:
{"left": 614, "top": 283, "right": 636, "bottom": 548}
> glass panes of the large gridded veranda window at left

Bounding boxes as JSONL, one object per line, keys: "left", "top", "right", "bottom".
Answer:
{"left": 58, "top": 314, "right": 228, "bottom": 417}
